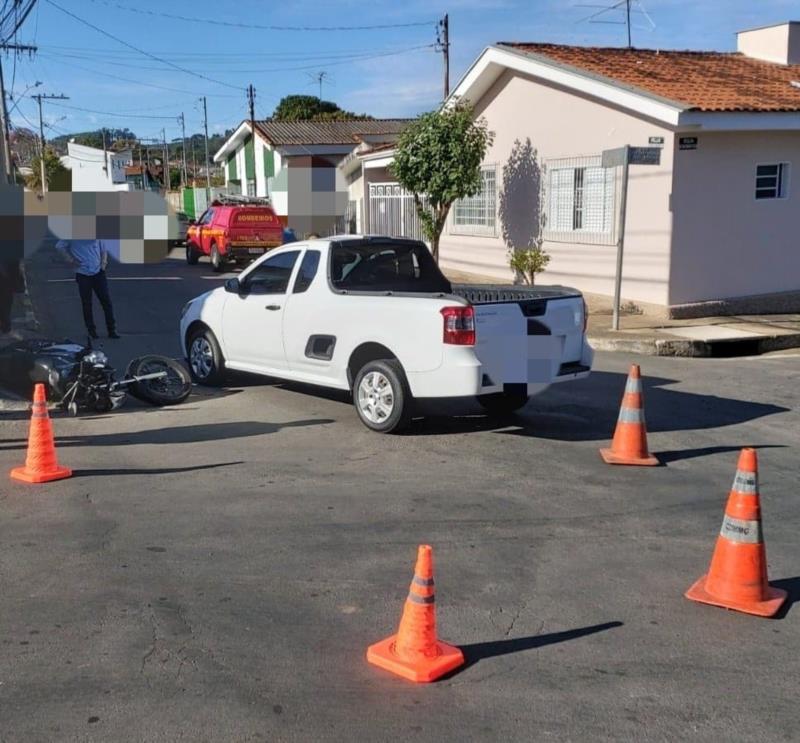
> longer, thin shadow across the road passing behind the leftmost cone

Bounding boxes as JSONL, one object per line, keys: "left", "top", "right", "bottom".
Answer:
{"left": 0, "top": 418, "right": 334, "bottom": 451}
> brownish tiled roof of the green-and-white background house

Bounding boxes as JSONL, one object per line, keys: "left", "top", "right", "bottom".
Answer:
{"left": 256, "top": 119, "right": 411, "bottom": 146}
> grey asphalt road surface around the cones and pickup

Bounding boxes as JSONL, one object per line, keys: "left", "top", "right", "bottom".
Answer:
{"left": 0, "top": 247, "right": 800, "bottom": 743}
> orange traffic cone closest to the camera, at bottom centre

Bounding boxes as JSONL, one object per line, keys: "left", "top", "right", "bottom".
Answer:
{"left": 367, "top": 544, "right": 464, "bottom": 683}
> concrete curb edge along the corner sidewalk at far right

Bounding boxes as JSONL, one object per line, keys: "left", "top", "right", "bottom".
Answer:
{"left": 587, "top": 333, "right": 800, "bottom": 358}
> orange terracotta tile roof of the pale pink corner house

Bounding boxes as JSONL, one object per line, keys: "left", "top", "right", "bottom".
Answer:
{"left": 498, "top": 42, "right": 800, "bottom": 111}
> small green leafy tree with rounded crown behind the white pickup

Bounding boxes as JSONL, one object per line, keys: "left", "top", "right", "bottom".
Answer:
{"left": 391, "top": 102, "right": 494, "bottom": 261}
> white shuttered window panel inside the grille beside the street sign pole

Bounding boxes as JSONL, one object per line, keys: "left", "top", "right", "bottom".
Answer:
{"left": 545, "top": 166, "right": 615, "bottom": 236}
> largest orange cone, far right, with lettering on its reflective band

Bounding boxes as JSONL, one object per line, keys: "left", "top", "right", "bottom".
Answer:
{"left": 686, "top": 449, "right": 787, "bottom": 617}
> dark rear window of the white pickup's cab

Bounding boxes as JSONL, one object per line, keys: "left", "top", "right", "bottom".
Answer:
{"left": 324, "top": 241, "right": 451, "bottom": 294}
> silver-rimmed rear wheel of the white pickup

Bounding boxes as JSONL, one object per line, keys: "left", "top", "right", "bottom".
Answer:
{"left": 353, "top": 359, "right": 413, "bottom": 433}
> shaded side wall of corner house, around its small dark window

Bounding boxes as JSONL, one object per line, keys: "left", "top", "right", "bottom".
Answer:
{"left": 669, "top": 132, "right": 800, "bottom": 304}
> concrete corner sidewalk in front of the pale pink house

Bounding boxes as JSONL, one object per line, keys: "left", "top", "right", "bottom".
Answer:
{"left": 445, "top": 270, "right": 800, "bottom": 357}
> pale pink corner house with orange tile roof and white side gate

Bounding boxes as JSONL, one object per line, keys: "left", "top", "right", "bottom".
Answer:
{"left": 345, "top": 23, "right": 800, "bottom": 316}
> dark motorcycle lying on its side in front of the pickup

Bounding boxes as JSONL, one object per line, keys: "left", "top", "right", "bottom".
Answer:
{"left": 0, "top": 340, "right": 192, "bottom": 416}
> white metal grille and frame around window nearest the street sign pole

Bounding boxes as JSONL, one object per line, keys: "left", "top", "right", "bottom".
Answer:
{"left": 541, "top": 155, "right": 622, "bottom": 245}
